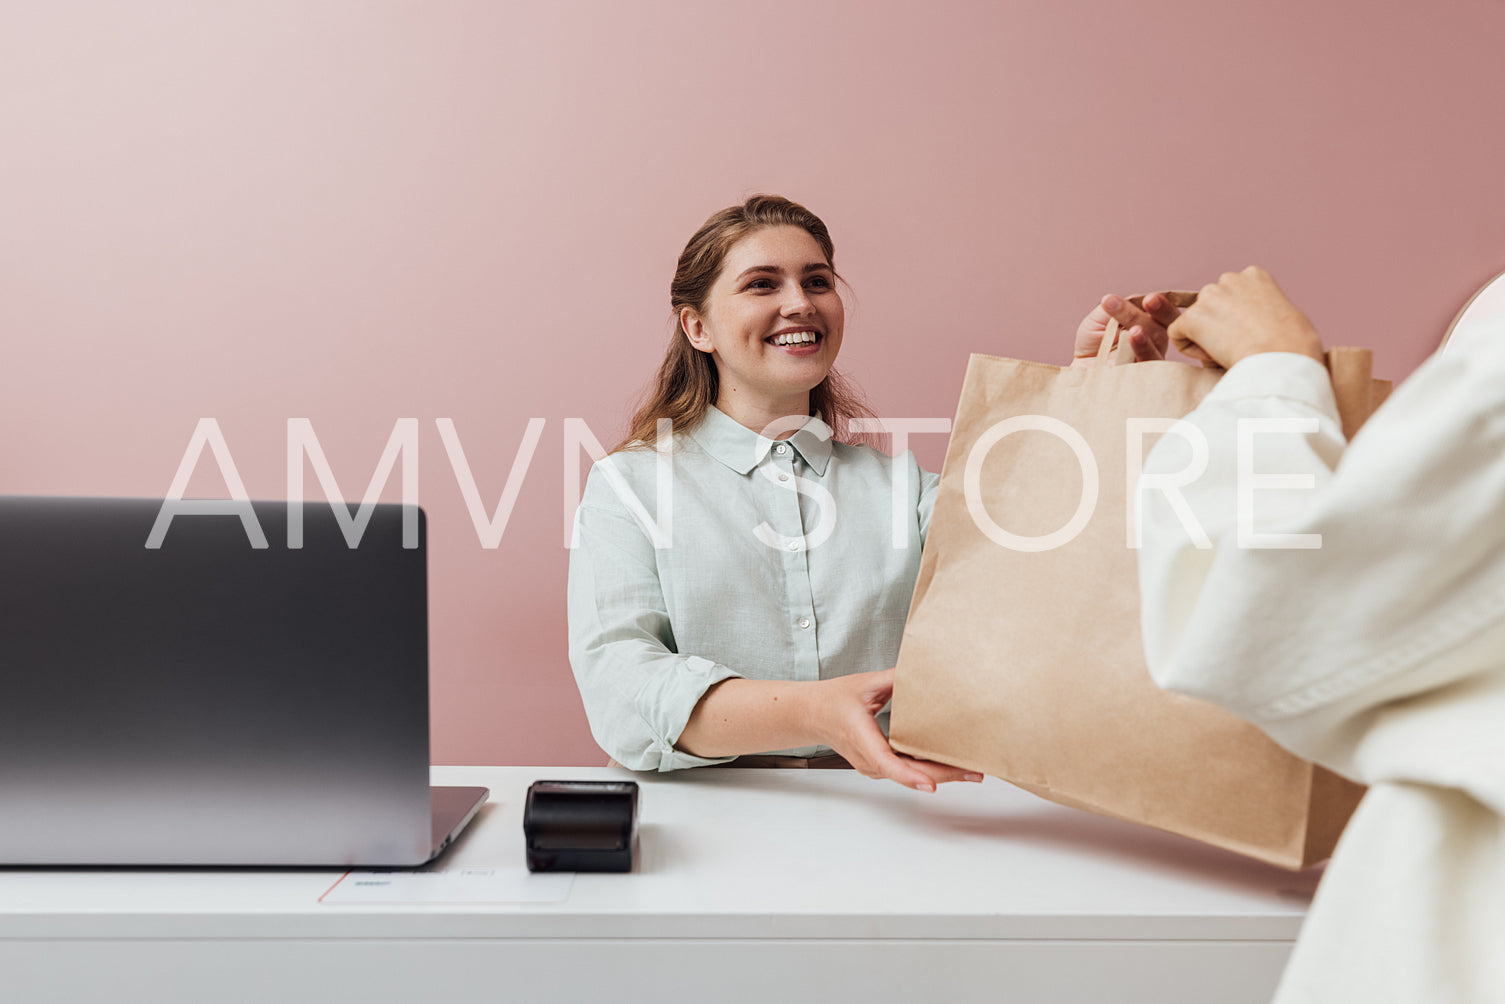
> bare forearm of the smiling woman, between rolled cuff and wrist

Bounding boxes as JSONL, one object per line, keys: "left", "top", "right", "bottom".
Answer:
{"left": 674, "top": 677, "right": 825, "bottom": 757}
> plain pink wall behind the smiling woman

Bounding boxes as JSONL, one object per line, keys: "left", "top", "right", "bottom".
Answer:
{"left": 0, "top": 0, "right": 1505, "bottom": 765}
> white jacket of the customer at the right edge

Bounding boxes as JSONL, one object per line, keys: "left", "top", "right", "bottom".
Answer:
{"left": 1139, "top": 340, "right": 1505, "bottom": 1004}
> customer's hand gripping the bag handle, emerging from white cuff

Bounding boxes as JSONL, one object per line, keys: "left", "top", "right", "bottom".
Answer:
{"left": 1169, "top": 265, "right": 1323, "bottom": 369}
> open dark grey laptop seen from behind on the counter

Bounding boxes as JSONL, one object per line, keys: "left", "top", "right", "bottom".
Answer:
{"left": 0, "top": 497, "right": 488, "bottom": 867}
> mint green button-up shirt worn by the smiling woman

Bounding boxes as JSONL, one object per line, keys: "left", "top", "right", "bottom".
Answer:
{"left": 569, "top": 408, "right": 941, "bottom": 771}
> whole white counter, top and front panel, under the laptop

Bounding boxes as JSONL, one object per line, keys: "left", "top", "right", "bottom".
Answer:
{"left": 0, "top": 768, "right": 1320, "bottom": 1004}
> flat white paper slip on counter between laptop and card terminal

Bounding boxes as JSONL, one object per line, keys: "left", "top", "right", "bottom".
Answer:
{"left": 319, "top": 867, "right": 575, "bottom": 903}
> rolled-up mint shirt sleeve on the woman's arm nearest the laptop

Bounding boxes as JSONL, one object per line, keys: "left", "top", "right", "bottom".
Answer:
{"left": 567, "top": 470, "right": 740, "bottom": 771}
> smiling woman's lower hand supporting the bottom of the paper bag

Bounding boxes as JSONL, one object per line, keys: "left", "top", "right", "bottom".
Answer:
{"left": 811, "top": 670, "right": 983, "bottom": 792}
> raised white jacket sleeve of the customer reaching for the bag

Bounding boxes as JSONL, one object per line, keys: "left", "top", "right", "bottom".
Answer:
{"left": 1139, "top": 346, "right": 1505, "bottom": 780}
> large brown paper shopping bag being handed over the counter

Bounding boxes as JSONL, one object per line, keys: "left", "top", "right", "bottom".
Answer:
{"left": 889, "top": 294, "right": 1388, "bottom": 869}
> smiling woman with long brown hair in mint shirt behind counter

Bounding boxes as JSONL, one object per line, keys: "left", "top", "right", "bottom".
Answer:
{"left": 569, "top": 196, "right": 1165, "bottom": 790}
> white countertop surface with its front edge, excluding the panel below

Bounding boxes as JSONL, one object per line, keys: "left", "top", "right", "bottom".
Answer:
{"left": 0, "top": 768, "right": 1320, "bottom": 942}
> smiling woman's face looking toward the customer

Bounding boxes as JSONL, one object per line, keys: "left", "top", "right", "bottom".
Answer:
{"left": 680, "top": 226, "right": 846, "bottom": 427}
